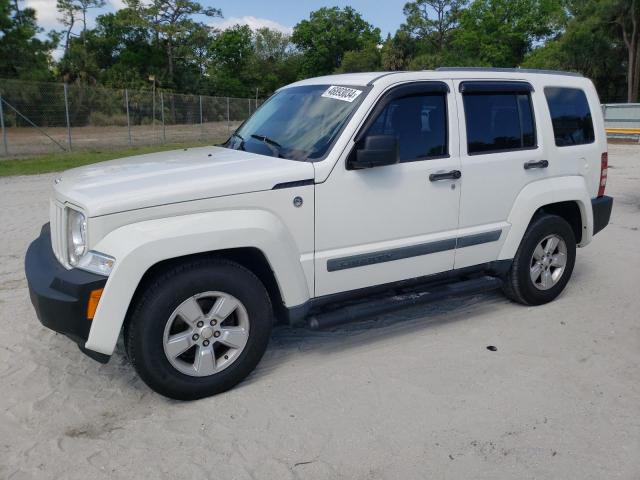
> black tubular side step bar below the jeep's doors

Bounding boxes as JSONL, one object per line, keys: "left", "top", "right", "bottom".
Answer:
{"left": 307, "top": 276, "right": 502, "bottom": 330}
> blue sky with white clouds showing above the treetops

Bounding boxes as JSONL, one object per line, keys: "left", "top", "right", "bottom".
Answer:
{"left": 22, "top": 0, "right": 406, "bottom": 57}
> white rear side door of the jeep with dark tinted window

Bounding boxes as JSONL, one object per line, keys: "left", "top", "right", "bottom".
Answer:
{"left": 455, "top": 80, "right": 552, "bottom": 268}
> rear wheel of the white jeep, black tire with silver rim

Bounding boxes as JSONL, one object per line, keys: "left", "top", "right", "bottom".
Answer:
{"left": 503, "top": 215, "right": 576, "bottom": 305}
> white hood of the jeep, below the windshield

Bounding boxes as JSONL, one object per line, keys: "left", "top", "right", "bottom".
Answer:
{"left": 54, "top": 147, "right": 314, "bottom": 217}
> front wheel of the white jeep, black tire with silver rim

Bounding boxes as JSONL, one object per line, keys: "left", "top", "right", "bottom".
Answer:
{"left": 125, "top": 259, "right": 273, "bottom": 400}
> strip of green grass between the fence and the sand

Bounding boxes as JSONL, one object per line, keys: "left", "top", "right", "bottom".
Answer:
{"left": 0, "top": 141, "right": 219, "bottom": 177}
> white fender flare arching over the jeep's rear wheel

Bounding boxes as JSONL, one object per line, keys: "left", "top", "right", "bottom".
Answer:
{"left": 498, "top": 176, "right": 593, "bottom": 260}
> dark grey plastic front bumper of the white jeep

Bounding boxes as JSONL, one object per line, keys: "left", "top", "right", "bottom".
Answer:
{"left": 24, "top": 223, "right": 110, "bottom": 363}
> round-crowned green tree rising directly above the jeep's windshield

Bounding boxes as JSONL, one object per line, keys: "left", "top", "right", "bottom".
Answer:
{"left": 291, "top": 7, "right": 380, "bottom": 76}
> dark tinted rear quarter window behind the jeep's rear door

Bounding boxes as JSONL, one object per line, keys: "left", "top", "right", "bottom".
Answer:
{"left": 544, "top": 87, "right": 595, "bottom": 147}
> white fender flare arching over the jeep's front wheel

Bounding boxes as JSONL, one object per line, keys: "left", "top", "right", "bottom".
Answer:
{"left": 85, "top": 210, "right": 310, "bottom": 355}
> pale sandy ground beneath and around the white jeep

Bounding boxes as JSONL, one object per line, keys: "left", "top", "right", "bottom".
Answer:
{"left": 0, "top": 145, "right": 640, "bottom": 480}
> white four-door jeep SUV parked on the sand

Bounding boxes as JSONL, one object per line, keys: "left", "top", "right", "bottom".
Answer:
{"left": 25, "top": 69, "right": 612, "bottom": 399}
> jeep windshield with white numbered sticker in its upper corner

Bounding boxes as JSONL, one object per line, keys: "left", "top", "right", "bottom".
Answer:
{"left": 223, "top": 85, "right": 365, "bottom": 161}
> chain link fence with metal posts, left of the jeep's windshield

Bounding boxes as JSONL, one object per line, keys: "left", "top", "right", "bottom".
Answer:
{"left": 0, "top": 80, "right": 262, "bottom": 158}
